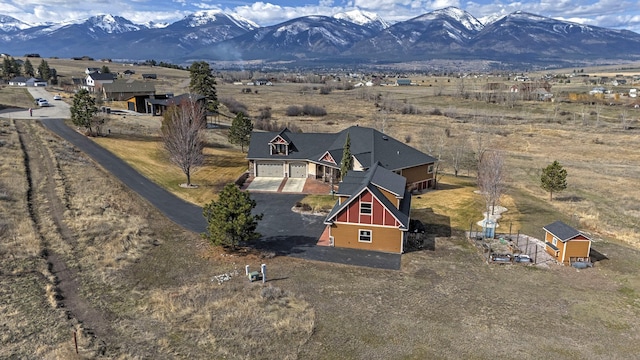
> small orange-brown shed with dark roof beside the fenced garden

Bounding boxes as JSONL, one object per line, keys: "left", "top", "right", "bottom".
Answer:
{"left": 543, "top": 221, "right": 591, "bottom": 265}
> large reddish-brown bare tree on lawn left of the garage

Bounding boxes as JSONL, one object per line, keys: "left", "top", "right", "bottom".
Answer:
{"left": 160, "top": 96, "right": 207, "bottom": 186}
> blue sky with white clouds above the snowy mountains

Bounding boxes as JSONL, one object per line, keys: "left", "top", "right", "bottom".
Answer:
{"left": 0, "top": 0, "right": 640, "bottom": 33}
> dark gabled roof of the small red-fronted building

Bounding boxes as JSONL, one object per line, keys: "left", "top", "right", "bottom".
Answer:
{"left": 324, "top": 164, "right": 411, "bottom": 230}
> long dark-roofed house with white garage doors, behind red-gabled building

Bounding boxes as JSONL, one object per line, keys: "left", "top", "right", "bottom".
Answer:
{"left": 247, "top": 126, "right": 436, "bottom": 190}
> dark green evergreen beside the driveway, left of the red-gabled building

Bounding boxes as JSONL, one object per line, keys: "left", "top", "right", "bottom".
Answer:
{"left": 202, "top": 184, "right": 262, "bottom": 250}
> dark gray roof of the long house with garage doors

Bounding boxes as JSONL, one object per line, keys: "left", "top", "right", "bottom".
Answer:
{"left": 247, "top": 126, "right": 436, "bottom": 170}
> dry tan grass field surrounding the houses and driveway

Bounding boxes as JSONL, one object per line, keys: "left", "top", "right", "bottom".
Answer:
{"left": 0, "top": 59, "right": 640, "bottom": 359}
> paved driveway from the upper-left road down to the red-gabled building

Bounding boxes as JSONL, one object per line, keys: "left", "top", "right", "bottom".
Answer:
{"left": 0, "top": 88, "right": 400, "bottom": 270}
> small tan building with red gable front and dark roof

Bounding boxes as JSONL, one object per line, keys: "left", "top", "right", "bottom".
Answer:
{"left": 323, "top": 164, "right": 411, "bottom": 253}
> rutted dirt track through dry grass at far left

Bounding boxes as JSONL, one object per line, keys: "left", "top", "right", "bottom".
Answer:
{"left": 16, "top": 120, "right": 113, "bottom": 352}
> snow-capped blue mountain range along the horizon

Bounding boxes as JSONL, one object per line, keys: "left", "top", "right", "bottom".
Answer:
{"left": 0, "top": 7, "right": 640, "bottom": 68}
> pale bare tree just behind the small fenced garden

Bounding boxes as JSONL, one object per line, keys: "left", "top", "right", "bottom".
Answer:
{"left": 478, "top": 150, "right": 506, "bottom": 215}
